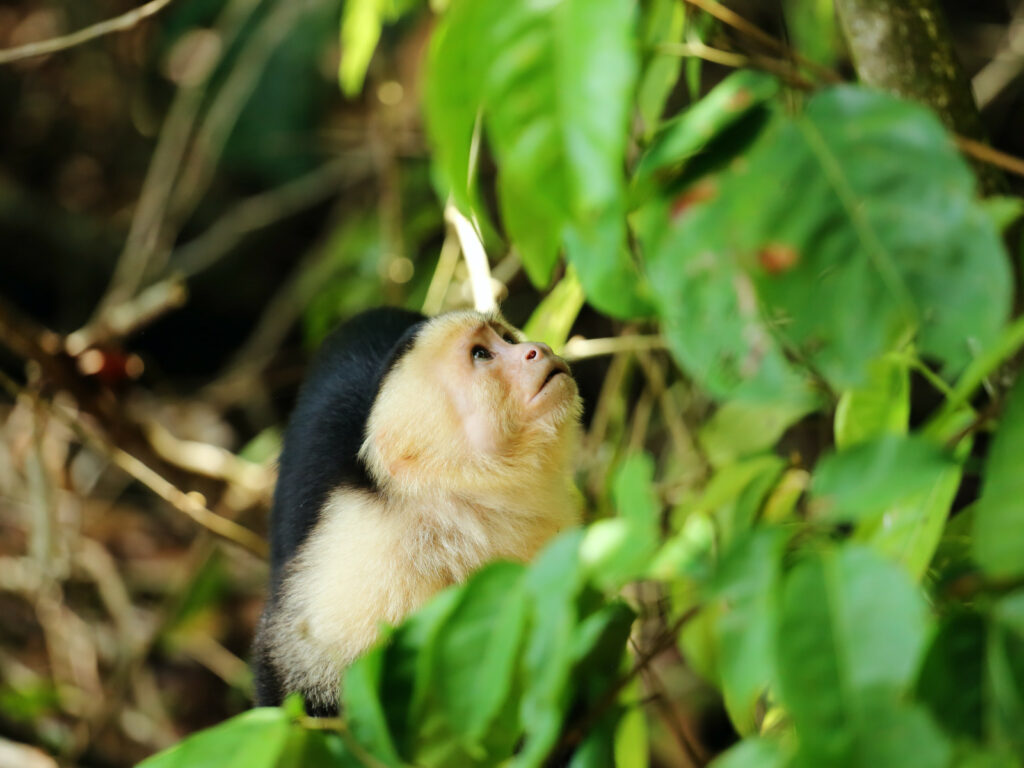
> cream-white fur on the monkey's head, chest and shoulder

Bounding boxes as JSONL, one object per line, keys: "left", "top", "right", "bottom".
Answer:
{"left": 266, "top": 313, "right": 580, "bottom": 706}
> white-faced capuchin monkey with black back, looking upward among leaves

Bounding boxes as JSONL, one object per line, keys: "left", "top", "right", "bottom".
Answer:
{"left": 255, "top": 309, "right": 581, "bottom": 716}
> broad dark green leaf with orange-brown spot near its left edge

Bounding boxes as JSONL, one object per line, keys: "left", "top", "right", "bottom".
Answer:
{"left": 730, "top": 86, "right": 1011, "bottom": 389}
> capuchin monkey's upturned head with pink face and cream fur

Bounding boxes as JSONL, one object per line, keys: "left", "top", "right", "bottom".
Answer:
{"left": 359, "top": 311, "right": 581, "bottom": 496}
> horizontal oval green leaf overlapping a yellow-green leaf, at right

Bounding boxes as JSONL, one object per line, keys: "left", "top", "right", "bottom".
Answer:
{"left": 811, "top": 435, "right": 954, "bottom": 520}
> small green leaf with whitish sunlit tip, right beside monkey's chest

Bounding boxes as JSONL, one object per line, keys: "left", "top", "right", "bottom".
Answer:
{"left": 580, "top": 454, "right": 660, "bottom": 590}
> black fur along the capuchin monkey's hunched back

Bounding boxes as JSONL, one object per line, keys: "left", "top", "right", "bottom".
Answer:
{"left": 270, "top": 307, "right": 426, "bottom": 599}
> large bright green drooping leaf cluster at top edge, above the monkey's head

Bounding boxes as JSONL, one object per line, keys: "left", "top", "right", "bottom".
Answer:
{"left": 427, "top": 0, "right": 650, "bottom": 316}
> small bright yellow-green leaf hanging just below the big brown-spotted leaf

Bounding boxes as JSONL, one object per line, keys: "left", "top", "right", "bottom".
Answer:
{"left": 836, "top": 357, "right": 910, "bottom": 450}
